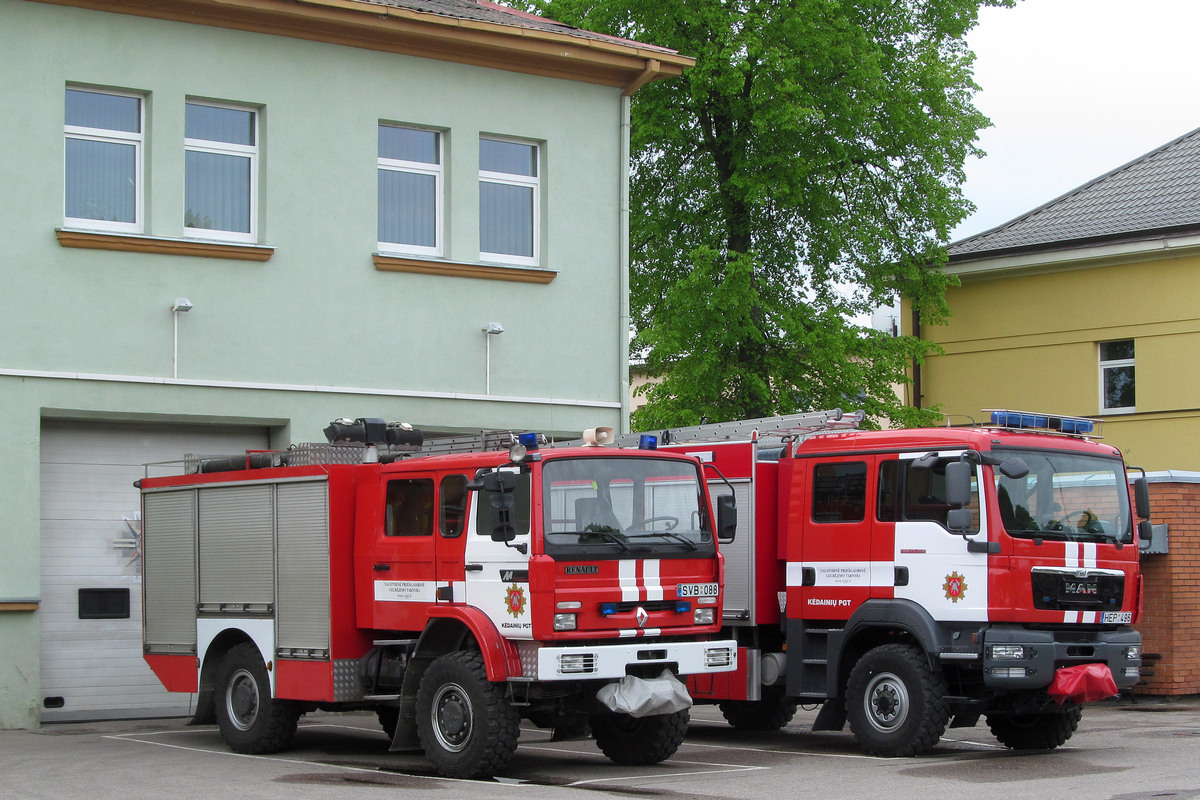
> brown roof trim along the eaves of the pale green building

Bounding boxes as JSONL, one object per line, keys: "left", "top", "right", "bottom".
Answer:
{"left": 31, "top": 0, "right": 695, "bottom": 94}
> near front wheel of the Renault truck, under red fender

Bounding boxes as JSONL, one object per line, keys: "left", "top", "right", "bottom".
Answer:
{"left": 416, "top": 651, "right": 520, "bottom": 778}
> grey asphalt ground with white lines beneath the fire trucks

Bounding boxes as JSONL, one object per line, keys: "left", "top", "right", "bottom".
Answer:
{"left": 0, "top": 698, "right": 1200, "bottom": 800}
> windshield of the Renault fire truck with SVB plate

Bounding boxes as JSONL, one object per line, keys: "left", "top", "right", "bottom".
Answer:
{"left": 542, "top": 458, "right": 714, "bottom": 559}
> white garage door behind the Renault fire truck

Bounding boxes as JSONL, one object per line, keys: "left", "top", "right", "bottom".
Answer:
{"left": 40, "top": 421, "right": 268, "bottom": 722}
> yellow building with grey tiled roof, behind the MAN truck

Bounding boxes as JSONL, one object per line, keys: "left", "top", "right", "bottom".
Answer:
{"left": 904, "top": 131, "right": 1200, "bottom": 470}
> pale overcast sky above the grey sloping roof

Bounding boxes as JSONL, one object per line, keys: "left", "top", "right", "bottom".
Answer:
{"left": 952, "top": 0, "right": 1200, "bottom": 241}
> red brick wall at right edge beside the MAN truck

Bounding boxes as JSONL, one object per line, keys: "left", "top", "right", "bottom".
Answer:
{"left": 1136, "top": 476, "right": 1200, "bottom": 694}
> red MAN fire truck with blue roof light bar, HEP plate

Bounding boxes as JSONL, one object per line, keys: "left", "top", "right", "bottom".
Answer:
{"left": 660, "top": 410, "right": 1150, "bottom": 756}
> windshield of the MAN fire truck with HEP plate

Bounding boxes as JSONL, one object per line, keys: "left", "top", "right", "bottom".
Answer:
{"left": 992, "top": 450, "right": 1133, "bottom": 542}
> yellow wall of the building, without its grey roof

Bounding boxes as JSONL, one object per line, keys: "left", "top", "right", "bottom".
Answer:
{"left": 904, "top": 257, "right": 1200, "bottom": 470}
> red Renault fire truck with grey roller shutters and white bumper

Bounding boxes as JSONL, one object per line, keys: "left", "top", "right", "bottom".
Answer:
{"left": 138, "top": 419, "right": 737, "bottom": 777}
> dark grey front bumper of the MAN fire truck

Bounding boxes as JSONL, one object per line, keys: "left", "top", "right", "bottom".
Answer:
{"left": 983, "top": 625, "right": 1141, "bottom": 688}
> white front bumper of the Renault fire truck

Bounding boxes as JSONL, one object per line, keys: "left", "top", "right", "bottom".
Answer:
{"left": 528, "top": 639, "right": 738, "bottom": 680}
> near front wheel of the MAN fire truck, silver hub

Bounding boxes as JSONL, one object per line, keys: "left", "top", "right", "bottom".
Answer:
{"left": 846, "top": 644, "right": 950, "bottom": 757}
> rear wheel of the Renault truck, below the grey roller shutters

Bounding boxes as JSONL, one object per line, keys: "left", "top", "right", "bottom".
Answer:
{"left": 212, "top": 642, "right": 300, "bottom": 756}
